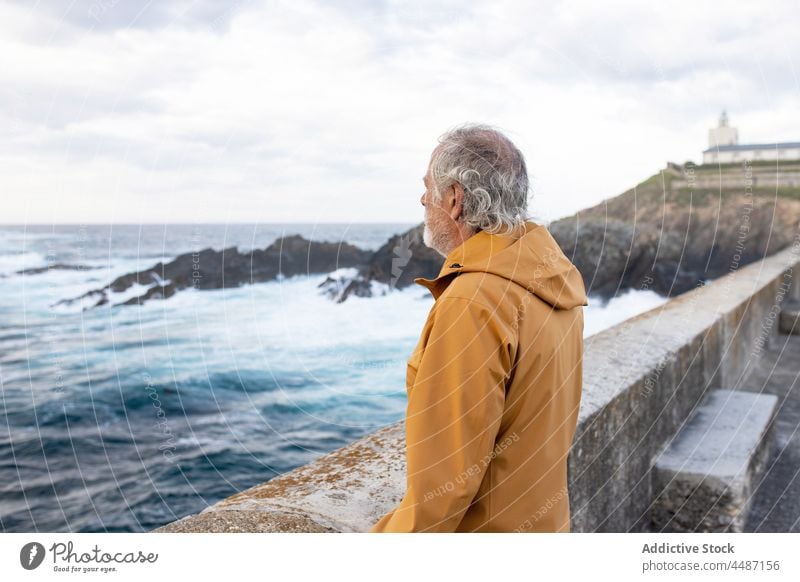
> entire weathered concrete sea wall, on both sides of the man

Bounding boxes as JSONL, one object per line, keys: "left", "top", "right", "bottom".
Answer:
{"left": 156, "top": 238, "right": 800, "bottom": 532}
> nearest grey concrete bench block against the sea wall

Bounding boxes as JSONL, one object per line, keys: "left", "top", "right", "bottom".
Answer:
{"left": 651, "top": 390, "right": 778, "bottom": 532}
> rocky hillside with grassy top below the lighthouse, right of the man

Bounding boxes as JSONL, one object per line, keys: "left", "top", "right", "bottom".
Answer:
{"left": 549, "top": 162, "right": 800, "bottom": 304}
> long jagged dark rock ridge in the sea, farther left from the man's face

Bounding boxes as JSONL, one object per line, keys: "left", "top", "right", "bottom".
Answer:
{"left": 59, "top": 235, "right": 371, "bottom": 307}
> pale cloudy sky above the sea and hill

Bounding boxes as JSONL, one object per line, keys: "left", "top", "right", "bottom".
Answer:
{"left": 0, "top": 0, "right": 800, "bottom": 223}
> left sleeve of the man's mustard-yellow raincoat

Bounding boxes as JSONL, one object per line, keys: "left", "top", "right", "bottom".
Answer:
{"left": 370, "top": 297, "right": 512, "bottom": 532}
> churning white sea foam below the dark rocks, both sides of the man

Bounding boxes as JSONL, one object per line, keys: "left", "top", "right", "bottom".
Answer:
{"left": 0, "top": 261, "right": 680, "bottom": 426}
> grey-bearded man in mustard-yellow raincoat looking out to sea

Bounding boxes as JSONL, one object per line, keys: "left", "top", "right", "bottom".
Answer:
{"left": 371, "top": 125, "right": 588, "bottom": 532}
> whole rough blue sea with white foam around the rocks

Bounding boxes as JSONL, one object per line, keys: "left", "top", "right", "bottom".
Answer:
{"left": 0, "top": 224, "right": 666, "bottom": 532}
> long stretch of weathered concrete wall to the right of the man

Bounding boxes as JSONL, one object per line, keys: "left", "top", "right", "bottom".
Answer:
{"left": 569, "top": 239, "right": 800, "bottom": 531}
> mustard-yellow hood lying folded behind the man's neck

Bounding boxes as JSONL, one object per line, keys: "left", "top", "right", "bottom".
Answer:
{"left": 414, "top": 222, "right": 589, "bottom": 309}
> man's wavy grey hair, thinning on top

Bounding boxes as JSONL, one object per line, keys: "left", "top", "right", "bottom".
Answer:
{"left": 430, "top": 124, "right": 529, "bottom": 234}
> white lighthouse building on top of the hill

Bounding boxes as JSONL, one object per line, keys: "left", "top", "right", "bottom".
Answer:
{"left": 703, "top": 111, "right": 800, "bottom": 164}
